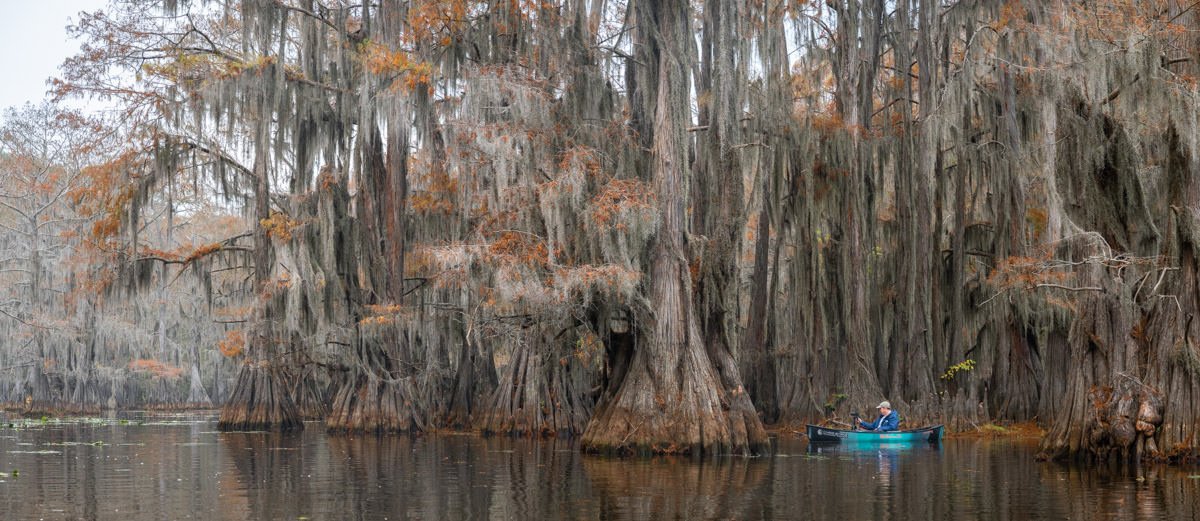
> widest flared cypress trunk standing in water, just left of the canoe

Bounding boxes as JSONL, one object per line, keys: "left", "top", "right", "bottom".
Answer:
{"left": 582, "top": 0, "right": 767, "bottom": 455}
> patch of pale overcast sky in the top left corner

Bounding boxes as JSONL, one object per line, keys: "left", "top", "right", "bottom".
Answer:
{"left": 0, "top": 0, "right": 108, "bottom": 118}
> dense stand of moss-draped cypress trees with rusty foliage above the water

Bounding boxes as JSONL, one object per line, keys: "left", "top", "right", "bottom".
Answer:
{"left": 7, "top": 0, "right": 1200, "bottom": 459}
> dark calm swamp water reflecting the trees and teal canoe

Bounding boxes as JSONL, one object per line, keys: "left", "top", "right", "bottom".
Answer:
{"left": 0, "top": 413, "right": 1200, "bottom": 521}
